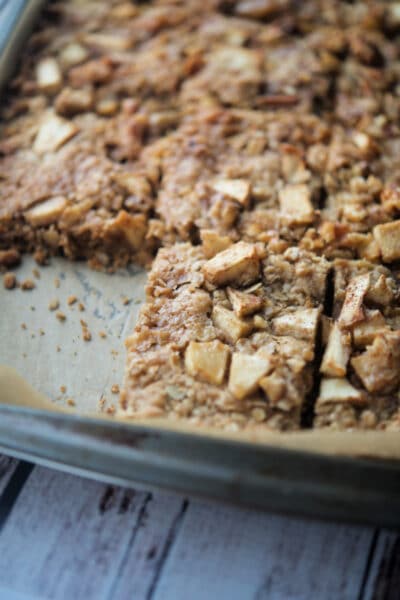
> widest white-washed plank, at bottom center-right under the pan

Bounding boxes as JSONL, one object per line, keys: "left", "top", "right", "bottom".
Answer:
{"left": 154, "top": 502, "right": 373, "bottom": 600}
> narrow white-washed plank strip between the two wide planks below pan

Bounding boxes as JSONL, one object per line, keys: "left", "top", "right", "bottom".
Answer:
{"left": 110, "top": 494, "right": 184, "bottom": 600}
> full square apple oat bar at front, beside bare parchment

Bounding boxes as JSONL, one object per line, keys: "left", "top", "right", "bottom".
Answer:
{"left": 120, "top": 242, "right": 329, "bottom": 429}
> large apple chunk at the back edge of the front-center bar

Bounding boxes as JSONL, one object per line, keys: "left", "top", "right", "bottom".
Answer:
{"left": 203, "top": 242, "right": 260, "bottom": 285}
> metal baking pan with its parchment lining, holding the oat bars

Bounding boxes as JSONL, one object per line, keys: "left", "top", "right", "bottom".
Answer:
{"left": 0, "top": 2, "right": 400, "bottom": 526}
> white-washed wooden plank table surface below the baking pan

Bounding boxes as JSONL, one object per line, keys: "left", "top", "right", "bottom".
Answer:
{"left": 0, "top": 457, "right": 400, "bottom": 600}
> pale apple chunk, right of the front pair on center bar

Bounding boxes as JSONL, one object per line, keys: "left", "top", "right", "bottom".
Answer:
{"left": 228, "top": 352, "right": 270, "bottom": 400}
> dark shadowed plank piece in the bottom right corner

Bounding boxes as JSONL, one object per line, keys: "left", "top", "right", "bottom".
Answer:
{"left": 361, "top": 530, "right": 400, "bottom": 600}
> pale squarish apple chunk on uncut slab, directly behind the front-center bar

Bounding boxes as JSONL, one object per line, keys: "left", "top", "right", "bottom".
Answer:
{"left": 279, "top": 183, "right": 314, "bottom": 225}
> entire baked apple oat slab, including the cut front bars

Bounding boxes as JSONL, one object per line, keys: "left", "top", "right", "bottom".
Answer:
{"left": 0, "top": 0, "right": 400, "bottom": 429}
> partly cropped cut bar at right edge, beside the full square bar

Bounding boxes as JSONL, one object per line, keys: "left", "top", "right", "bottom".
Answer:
{"left": 314, "top": 259, "right": 400, "bottom": 429}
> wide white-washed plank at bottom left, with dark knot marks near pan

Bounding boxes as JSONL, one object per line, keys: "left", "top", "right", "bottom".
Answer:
{"left": 0, "top": 467, "right": 152, "bottom": 600}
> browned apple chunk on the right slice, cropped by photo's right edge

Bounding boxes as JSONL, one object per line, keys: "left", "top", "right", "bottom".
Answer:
{"left": 351, "top": 331, "right": 400, "bottom": 394}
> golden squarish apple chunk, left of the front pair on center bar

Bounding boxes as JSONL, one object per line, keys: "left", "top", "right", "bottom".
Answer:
{"left": 185, "top": 340, "right": 230, "bottom": 385}
